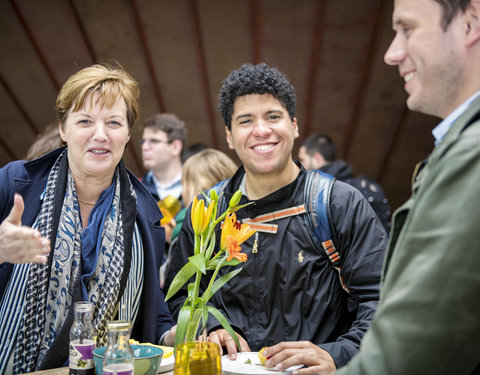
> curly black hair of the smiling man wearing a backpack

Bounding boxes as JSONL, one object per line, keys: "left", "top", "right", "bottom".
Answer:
{"left": 218, "top": 63, "right": 295, "bottom": 130}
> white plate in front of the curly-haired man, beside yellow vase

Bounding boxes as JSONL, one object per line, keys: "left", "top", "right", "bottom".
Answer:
{"left": 222, "top": 352, "right": 303, "bottom": 375}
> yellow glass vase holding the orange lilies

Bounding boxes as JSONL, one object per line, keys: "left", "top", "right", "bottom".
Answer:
{"left": 173, "top": 341, "right": 222, "bottom": 375}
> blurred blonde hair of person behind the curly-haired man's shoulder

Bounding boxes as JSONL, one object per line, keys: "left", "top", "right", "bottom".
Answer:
{"left": 182, "top": 148, "right": 237, "bottom": 205}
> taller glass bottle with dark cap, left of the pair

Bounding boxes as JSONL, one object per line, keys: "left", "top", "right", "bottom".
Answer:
{"left": 69, "top": 302, "right": 96, "bottom": 375}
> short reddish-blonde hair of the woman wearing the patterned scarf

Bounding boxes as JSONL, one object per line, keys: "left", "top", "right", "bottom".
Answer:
{"left": 56, "top": 64, "right": 140, "bottom": 129}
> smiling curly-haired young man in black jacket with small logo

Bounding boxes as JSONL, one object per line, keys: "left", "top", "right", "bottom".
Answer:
{"left": 166, "top": 64, "right": 387, "bottom": 371}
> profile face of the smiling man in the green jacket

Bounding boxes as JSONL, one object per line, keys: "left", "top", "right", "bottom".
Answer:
{"left": 385, "top": 0, "right": 466, "bottom": 118}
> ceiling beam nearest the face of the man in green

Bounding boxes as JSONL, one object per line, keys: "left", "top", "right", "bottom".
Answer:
{"left": 343, "top": 0, "right": 388, "bottom": 161}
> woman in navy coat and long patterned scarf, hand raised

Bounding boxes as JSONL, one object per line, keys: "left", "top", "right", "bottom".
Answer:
{"left": 0, "top": 65, "right": 176, "bottom": 374}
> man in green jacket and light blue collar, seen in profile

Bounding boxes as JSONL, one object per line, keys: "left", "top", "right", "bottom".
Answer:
{"left": 264, "top": 0, "right": 480, "bottom": 375}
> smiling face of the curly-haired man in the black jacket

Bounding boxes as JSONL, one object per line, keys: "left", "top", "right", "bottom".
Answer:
{"left": 226, "top": 94, "right": 299, "bottom": 175}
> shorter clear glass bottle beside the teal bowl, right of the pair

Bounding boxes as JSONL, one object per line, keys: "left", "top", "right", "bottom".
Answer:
{"left": 103, "top": 321, "right": 133, "bottom": 375}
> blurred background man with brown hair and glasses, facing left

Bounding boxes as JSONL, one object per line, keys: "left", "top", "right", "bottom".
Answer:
{"left": 141, "top": 113, "right": 187, "bottom": 201}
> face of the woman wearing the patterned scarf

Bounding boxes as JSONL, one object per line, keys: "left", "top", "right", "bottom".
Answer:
{"left": 60, "top": 94, "right": 130, "bottom": 183}
